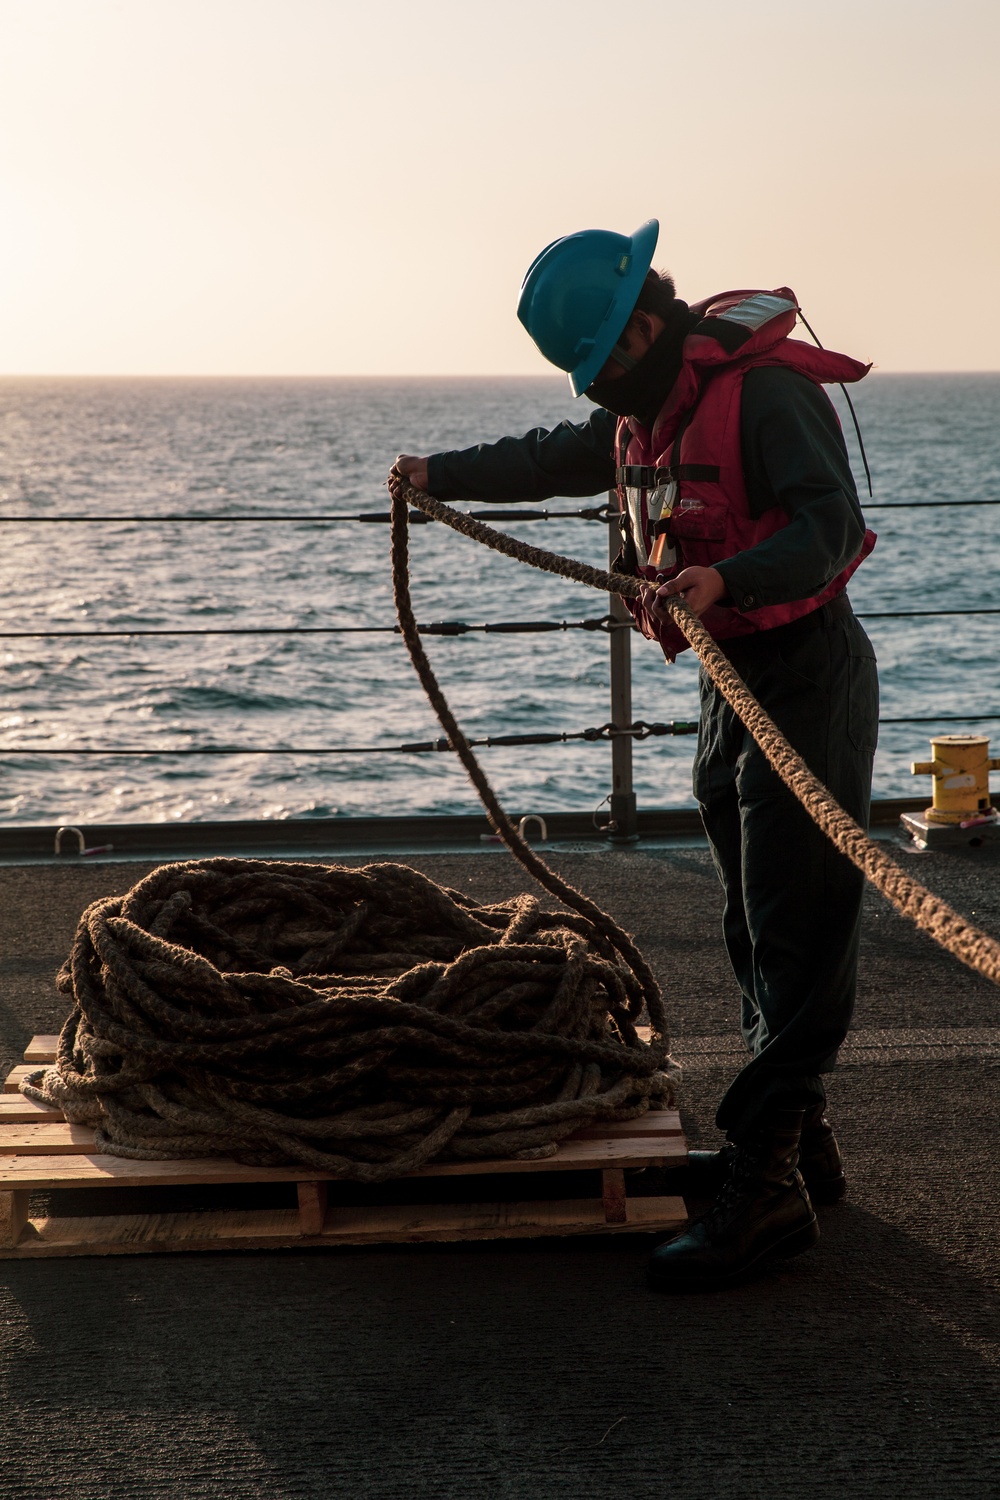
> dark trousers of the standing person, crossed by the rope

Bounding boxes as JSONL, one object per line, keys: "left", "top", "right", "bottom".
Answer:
{"left": 694, "top": 596, "right": 879, "bottom": 1140}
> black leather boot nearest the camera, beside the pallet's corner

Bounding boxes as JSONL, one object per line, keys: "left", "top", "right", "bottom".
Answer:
{"left": 648, "top": 1110, "right": 820, "bottom": 1292}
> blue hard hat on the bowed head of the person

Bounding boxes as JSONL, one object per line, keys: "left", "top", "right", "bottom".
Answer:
{"left": 517, "top": 219, "right": 660, "bottom": 396}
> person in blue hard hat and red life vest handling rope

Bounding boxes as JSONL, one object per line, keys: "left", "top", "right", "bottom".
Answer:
{"left": 396, "top": 219, "right": 879, "bottom": 1292}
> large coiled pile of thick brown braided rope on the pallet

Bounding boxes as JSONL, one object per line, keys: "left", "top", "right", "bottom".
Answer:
{"left": 21, "top": 860, "right": 673, "bottom": 1182}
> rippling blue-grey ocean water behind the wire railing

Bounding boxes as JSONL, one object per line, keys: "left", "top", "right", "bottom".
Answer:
{"left": 0, "top": 374, "right": 1000, "bottom": 824}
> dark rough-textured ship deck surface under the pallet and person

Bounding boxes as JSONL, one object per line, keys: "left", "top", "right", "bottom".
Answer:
{"left": 0, "top": 839, "right": 1000, "bottom": 1500}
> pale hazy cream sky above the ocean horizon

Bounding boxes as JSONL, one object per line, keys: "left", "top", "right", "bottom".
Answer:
{"left": 0, "top": 0, "right": 1000, "bottom": 374}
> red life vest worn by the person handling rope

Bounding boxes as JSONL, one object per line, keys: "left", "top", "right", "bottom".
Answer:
{"left": 615, "top": 287, "right": 876, "bottom": 660}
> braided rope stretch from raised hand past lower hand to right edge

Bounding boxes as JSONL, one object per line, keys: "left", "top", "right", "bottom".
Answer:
{"left": 388, "top": 470, "right": 1000, "bottom": 984}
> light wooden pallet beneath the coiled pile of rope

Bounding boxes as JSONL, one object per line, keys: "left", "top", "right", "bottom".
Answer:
{"left": 0, "top": 1037, "right": 687, "bottom": 1260}
